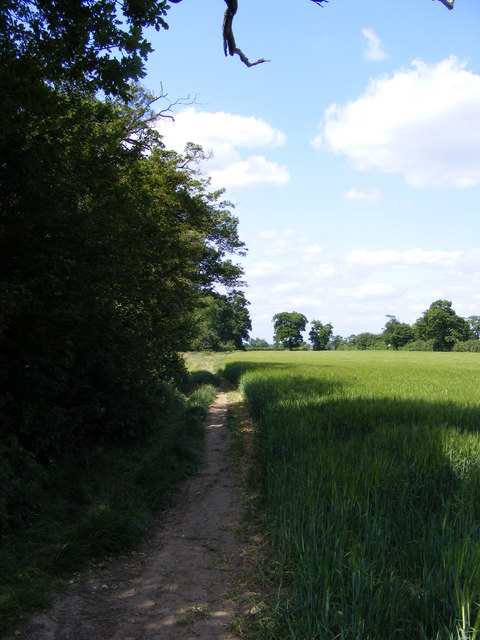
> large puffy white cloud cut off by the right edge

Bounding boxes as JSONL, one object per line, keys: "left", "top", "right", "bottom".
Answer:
{"left": 312, "top": 56, "right": 480, "bottom": 188}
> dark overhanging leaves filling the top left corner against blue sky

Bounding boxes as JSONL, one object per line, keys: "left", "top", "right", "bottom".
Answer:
{"left": 0, "top": 0, "right": 174, "bottom": 99}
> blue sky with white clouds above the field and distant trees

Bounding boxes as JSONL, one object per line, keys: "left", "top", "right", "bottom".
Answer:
{"left": 143, "top": 0, "right": 480, "bottom": 341}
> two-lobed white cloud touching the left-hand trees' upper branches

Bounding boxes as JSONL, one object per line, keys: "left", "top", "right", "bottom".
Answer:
{"left": 158, "top": 107, "right": 290, "bottom": 187}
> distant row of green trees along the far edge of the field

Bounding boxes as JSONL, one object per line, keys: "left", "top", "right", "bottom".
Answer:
{"left": 246, "top": 300, "right": 480, "bottom": 351}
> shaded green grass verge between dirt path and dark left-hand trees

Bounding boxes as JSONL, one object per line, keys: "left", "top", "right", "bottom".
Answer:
{"left": 0, "top": 384, "right": 216, "bottom": 635}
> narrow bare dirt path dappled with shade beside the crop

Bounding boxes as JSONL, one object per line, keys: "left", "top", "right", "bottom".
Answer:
{"left": 10, "top": 392, "right": 248, "bottom": 640}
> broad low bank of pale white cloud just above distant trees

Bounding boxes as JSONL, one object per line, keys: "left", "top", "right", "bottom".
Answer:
{"left": 244, "top": 229, "right": 480, "bottom": 340}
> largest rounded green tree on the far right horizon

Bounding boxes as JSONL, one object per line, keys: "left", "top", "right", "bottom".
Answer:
{"left": 414, "top": 300, "right": 472, "bottom": 351}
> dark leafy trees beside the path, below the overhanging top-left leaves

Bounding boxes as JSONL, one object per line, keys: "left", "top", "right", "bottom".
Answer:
{"left": 0, "top": 86, "right": 243, "bottom": 461}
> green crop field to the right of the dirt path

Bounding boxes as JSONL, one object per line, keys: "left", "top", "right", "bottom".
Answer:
{"left": 225, "top": 352, "right": 480, "bottom": 640}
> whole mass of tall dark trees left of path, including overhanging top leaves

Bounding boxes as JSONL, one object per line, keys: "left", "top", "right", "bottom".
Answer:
{"left": 0, "top": 0, "right": 249, "bottom": 476}
